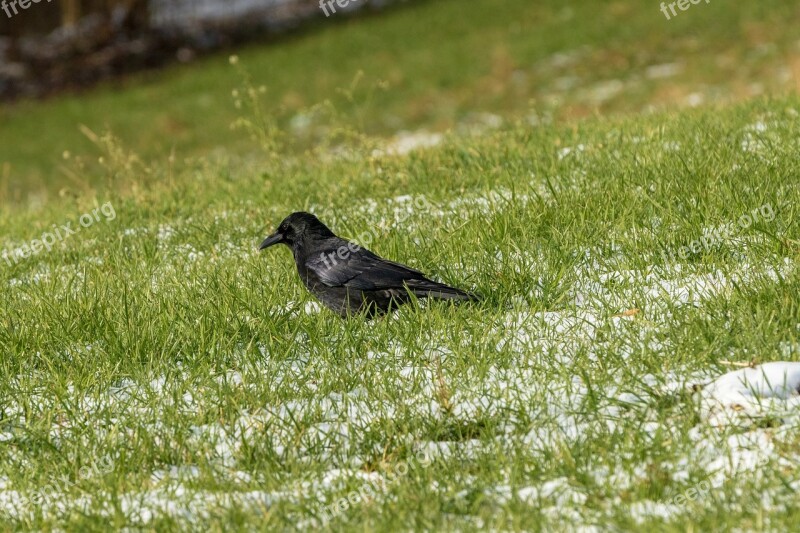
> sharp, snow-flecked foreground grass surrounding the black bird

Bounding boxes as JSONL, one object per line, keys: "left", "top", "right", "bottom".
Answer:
{"left": 0, "top": 92, "right": 800, "bottom": 530}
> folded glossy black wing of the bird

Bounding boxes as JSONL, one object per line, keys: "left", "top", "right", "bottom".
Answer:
{"left": 305, "top": 242, "right": 425, "bottom": 290}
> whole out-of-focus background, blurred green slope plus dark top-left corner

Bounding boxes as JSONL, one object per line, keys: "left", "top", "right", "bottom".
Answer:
{"left": 0, "top": 0, "right": 800, "bottom": 204}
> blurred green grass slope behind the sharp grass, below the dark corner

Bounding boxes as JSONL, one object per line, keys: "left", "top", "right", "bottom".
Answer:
{"left": 0, "top": 0, "right": 800, "bottom": 198}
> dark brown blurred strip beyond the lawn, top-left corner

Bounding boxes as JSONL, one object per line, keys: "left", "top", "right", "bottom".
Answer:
{"left": 0, "top": 0, "right": 382, "bottom": 100}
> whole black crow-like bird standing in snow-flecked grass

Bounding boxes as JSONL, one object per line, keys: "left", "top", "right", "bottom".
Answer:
{"left": 259, "top": 212, "right": 480, "bottom": 317}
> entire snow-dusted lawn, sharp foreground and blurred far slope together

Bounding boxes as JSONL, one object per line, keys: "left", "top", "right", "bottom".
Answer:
{"left": 0, "top": 0, "right": 800, "bottom": 531}
